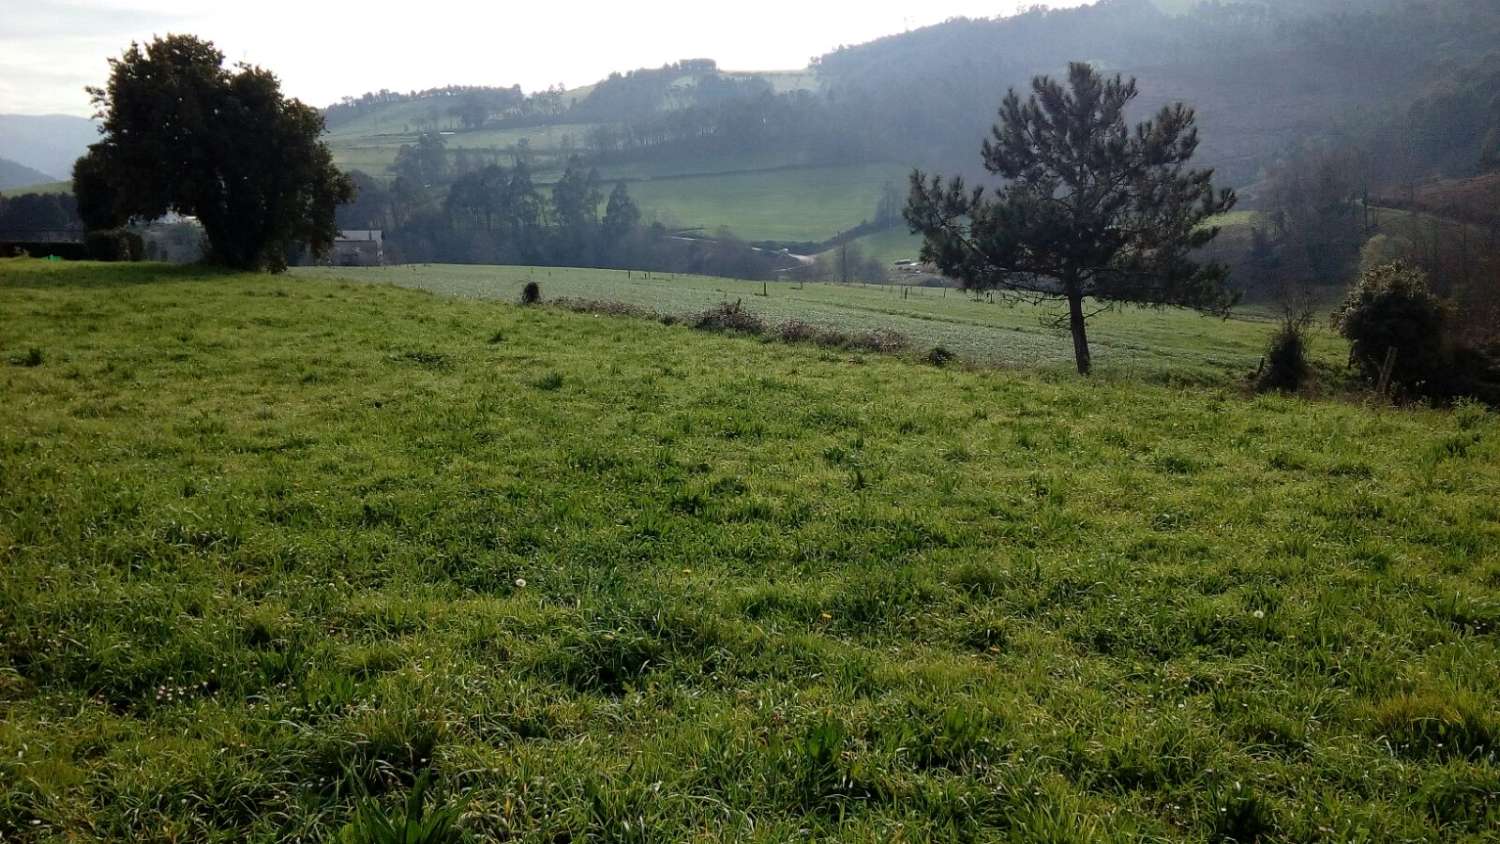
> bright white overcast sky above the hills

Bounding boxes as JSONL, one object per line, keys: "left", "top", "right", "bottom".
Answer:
{"left": 0, "top": 0, "right": 1082, "bottom": 115}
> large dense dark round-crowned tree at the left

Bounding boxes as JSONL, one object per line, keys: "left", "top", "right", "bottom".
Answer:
{"left": 74, "top": 36, "right": 354, "bottom": 271}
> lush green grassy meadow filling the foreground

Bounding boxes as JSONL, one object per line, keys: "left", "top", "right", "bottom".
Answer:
{"left": 0, "top": 261, "right": 1500, "bottom": 843}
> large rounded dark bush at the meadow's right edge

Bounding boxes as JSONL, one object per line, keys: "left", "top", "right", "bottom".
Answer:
{"left": 1334, "top": 261, "right": 1448, "bottom": 394}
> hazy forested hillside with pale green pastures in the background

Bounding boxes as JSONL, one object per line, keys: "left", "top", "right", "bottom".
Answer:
{"left": 327, "top": 0, "right": 1500, "bottom": 286}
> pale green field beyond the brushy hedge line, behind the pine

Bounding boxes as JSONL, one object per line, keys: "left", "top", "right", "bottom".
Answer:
{"left": 294, "top": 265, "right": 1349, "bottom": 384}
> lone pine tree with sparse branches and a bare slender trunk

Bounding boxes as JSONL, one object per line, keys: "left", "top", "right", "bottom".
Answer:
{"left": 906, "top": 63, "right": 1235, "bottom": 373}
